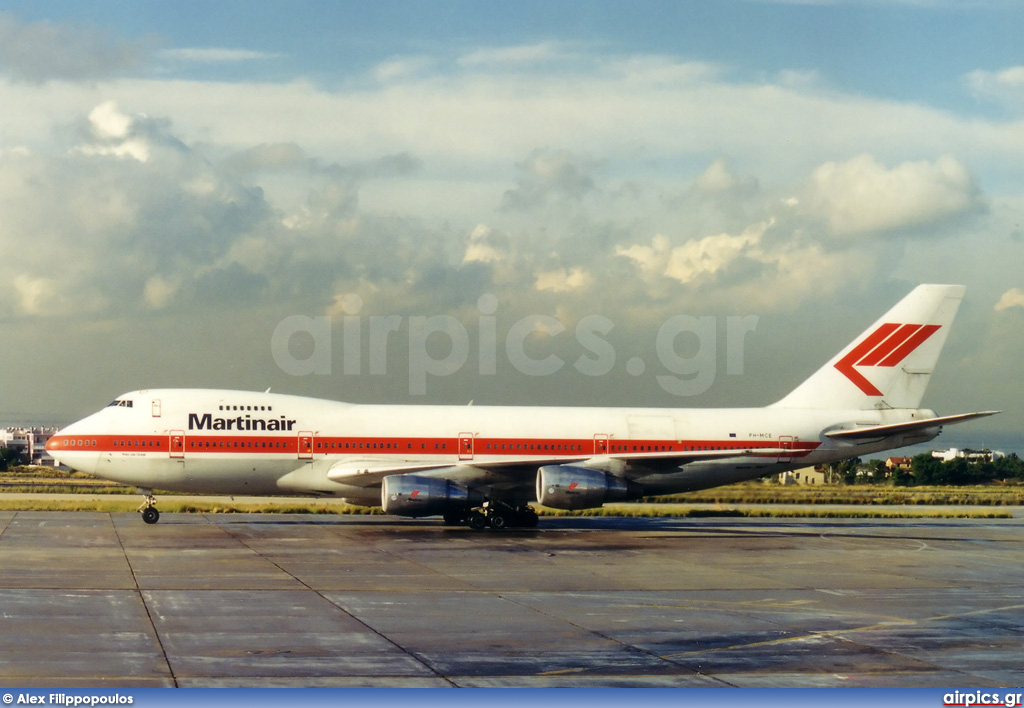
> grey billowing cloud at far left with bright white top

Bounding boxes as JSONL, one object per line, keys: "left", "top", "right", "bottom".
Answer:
{"left": 0, "top": 102, "right": 280, "bottom": 317}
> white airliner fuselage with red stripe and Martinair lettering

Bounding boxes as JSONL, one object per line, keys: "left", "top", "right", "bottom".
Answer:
{"left": 47, "top": 389, "right": 938, "bottom": 505}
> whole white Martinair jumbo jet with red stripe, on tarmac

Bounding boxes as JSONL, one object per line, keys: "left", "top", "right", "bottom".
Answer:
{"left": 46, "top": 285, "right": 997, "bottom": 529}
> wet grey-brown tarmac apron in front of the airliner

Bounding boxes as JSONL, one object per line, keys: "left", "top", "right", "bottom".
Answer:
{"left": 0, "top": 511, "right": 1024, "bottom": 688}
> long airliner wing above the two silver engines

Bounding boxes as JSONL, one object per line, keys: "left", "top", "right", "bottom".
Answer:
{"left": 327, "top": 448, "right": 778, "bottom": 487}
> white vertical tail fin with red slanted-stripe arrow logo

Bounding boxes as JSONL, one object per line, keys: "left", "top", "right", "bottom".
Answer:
{"left": 774, "top": 285, "right": 966, "bottom": 410}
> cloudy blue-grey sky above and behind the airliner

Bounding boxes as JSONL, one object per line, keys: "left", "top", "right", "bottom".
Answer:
{"left": 0, "top": 0, "right": 1024, "bottom": 450}
